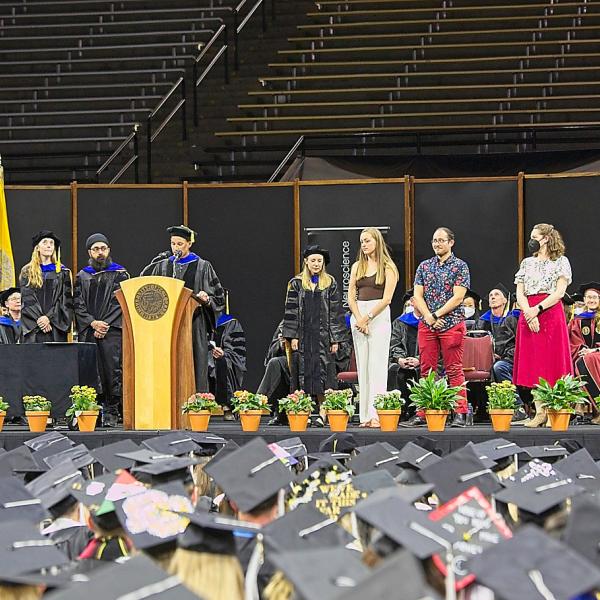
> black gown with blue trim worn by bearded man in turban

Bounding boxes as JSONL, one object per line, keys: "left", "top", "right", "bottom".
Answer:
{"left": 73, "top": 263, "right": 129, "bottom": 412}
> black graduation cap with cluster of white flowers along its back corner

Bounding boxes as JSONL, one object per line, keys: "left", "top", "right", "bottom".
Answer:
{"left": 495, "top": 458, "right": 585, "bottom": 515}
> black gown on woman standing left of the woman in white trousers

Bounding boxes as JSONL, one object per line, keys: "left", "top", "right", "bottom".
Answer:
{"left": 283, "top": 277, "right": 346, "bottom": 395}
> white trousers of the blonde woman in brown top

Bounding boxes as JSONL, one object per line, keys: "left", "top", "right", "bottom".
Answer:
{"left": 350, "top": 300, "right": 392, "bottom": 423}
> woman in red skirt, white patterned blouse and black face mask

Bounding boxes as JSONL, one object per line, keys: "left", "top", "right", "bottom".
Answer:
{"left": 513, "top": 223, "right": 573, "bottom": 427}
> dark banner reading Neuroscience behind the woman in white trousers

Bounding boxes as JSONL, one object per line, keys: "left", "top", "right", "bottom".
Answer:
{"left": 304, "top": 225, "right": 390, "bottom": 308}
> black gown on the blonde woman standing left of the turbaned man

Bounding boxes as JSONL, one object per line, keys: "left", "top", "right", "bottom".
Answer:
{"left": 19, "top": 265, "right": 73, "bottom": 344}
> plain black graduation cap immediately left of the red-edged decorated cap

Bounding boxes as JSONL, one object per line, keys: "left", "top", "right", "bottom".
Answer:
{"left": 354, "top": 493, "right": 454, "bottom": 559}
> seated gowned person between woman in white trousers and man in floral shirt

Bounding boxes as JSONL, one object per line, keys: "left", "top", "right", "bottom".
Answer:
{"left": 388, "top": 290, "right": 419, "bottom": 400}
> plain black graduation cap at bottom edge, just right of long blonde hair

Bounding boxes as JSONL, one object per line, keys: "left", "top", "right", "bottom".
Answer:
{"left": 270, "top": 548, "right": 369, "bottom": 600}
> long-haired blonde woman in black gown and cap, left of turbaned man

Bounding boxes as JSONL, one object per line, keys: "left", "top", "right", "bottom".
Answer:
{"left": 19, "top": 230, "right": 73, "bottom": 344}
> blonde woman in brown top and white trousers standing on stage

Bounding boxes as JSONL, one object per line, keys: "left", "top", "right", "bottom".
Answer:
{"left": 348, "top": 227, "right": 399, "bottom": 427}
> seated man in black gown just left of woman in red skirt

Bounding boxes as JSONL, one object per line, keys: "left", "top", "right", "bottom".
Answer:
{"left": 475, "top": 283, "right": 527, "bottom": 422}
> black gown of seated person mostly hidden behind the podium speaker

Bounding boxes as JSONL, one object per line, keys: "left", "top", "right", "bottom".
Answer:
{"left": 208, "top": 317, "right": 246, "bottom": 406}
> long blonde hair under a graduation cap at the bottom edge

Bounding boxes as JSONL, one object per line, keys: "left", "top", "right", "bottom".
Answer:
{"left": 168, "top": 548, "right": 244, "bottom": 600}
